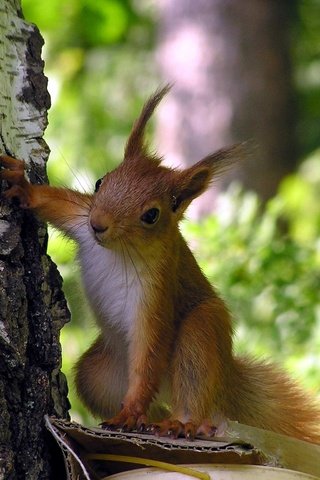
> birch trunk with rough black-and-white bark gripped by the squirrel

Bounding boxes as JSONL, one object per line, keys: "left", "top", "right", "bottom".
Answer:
{"left": 0, "top": 0, "right": 69, "bottom": 480}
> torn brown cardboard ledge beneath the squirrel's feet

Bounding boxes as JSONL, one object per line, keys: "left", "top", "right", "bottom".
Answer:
{"left": 45, "top": 416, "right": 320, "bottom": 480}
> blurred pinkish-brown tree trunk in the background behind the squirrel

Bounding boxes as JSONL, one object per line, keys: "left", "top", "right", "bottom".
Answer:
{"left": 158, "top": 0, "right": 296, "bottom": 215}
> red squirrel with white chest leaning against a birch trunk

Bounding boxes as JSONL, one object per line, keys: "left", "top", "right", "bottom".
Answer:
{"left": 0, "top": 86, "right": 320, "bottom": 443}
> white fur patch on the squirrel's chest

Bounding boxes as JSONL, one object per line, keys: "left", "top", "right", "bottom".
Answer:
{"left": 79, "top": 238, "right": 142, "bottom": 333}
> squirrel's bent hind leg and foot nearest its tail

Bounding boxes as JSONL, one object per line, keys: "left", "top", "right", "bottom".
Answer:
{"left": 148, "top": 297, "right": 232, "bottom": 440}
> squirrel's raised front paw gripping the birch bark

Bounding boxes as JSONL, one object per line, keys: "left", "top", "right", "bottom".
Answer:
{"left": 0, "top": 155, "right": 30, "bottom": 208}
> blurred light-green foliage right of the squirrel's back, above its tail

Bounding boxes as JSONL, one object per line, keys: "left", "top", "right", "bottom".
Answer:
{"left": 183, "top": 151, "right": 320, "bottom": 388}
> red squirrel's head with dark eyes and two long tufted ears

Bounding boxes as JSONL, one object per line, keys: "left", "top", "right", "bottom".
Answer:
{"left": 89, "top": 86, "right": 239, "bottom": 253}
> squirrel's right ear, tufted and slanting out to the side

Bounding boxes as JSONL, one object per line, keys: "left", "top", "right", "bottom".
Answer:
{"left": 172, "top": 143, "right": 245, "bottom": 212}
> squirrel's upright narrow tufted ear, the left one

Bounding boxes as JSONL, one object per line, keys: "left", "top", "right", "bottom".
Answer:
{"left": 124, "top": 84, "right": 171, "bottom": 160}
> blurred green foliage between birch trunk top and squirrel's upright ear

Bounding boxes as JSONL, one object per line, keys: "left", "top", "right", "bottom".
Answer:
{"left": 22, "top": 0, "right": 159, "bottom": 190}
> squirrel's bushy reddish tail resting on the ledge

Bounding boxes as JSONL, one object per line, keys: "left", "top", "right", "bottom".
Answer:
{"left": 225, "top": 357, "right": 320, "bottom": 444}
